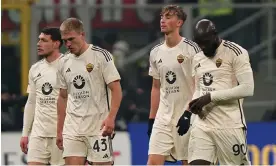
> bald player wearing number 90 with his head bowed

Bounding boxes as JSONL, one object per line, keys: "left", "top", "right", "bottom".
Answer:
{"left": 188, "top": 19, "right": 254, "bottom": 165}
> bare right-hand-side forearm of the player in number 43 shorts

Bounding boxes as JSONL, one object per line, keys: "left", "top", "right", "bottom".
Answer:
{"left": 109, "top": 88, "right": 123, "bottom": 119}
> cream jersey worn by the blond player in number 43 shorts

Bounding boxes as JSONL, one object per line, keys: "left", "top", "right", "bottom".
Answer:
{"left": 58, "top": 45, "right": 120, "bottom": 136}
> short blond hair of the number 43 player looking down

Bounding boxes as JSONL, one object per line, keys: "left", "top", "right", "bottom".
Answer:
{"left": 60, "top": 18, "right": 84, "bottom": 33}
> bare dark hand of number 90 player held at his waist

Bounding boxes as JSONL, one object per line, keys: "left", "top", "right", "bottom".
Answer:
{"left": 189, "top": 93, "right": 211, "bottom": 114}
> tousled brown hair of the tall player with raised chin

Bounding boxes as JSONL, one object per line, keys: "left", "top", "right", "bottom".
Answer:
{"left": 160, "top": 5, "right": 187, "bottom": 23}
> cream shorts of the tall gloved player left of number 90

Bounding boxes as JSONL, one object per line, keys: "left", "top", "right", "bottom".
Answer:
{"left": 148, "top": 120, "right": 190, "bottom": 162}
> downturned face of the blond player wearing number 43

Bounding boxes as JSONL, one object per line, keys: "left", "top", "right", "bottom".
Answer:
{"left": 61, "top": 31, "right": 84, "bottom": 55}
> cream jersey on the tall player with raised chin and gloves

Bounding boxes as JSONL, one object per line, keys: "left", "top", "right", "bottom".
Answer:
{"left": 149, "top": 38, "right": 201, "bottom": 125}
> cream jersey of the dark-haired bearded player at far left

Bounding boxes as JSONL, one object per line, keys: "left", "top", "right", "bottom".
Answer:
{"left": 27, "top": 55, "right": 63, "bottom": 137}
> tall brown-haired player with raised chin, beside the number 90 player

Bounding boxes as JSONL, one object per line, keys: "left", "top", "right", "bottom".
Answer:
{"left": 147, "top": 5, "right": 201, "bottom": 165}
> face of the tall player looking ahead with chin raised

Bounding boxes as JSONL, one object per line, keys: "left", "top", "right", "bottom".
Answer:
{"left": 160, "top": 11, "right": 182, "bottom": 34}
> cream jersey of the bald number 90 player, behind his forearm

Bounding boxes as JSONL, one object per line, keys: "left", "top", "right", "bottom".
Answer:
{"left": 193, "top": 40, "right": 252, "bottom": 128}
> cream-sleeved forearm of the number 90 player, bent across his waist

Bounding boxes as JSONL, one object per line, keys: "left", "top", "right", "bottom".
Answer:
{"left": 211, "top": 72, "right": 254, "bottom": 102}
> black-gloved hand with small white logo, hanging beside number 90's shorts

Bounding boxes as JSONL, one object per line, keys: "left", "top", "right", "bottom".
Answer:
{"left": 176, "top": 111, "right": 192, "bottom": 136}
